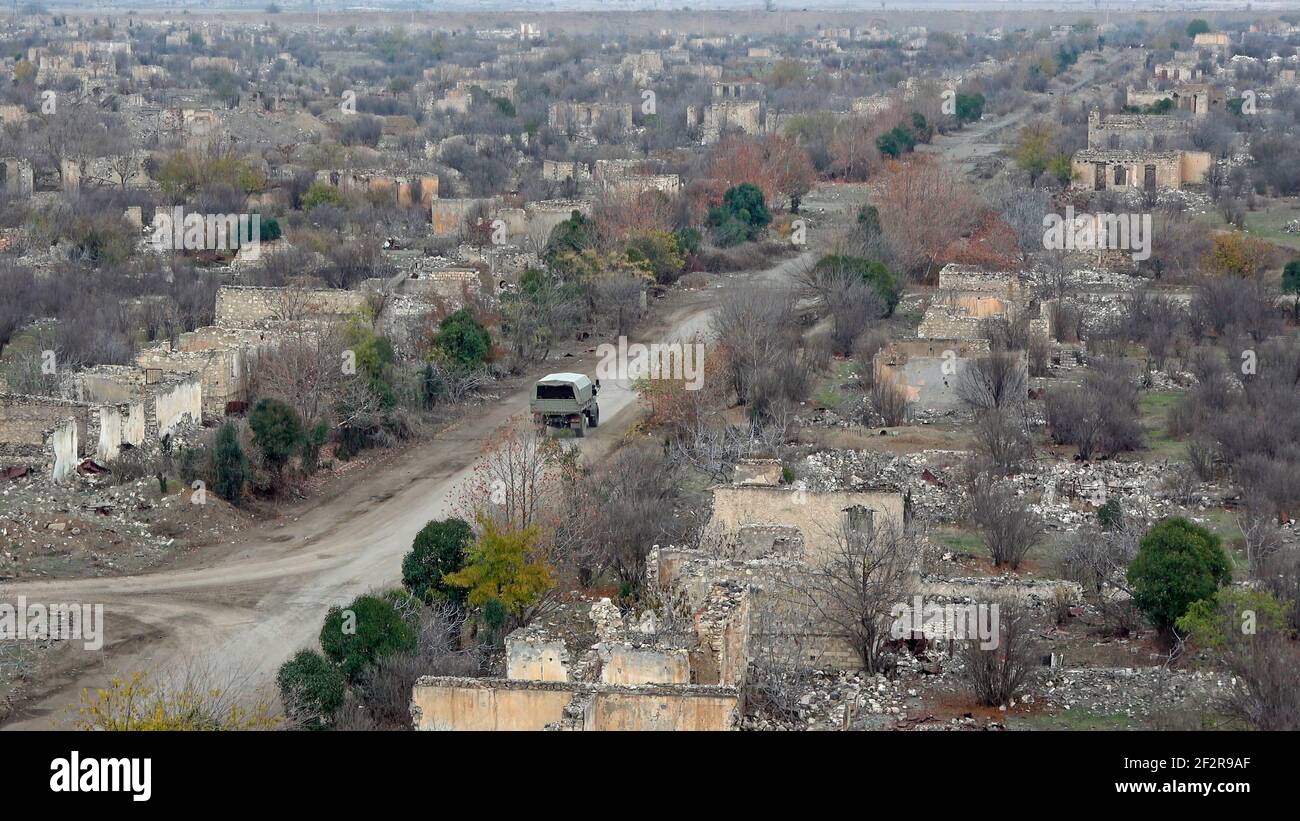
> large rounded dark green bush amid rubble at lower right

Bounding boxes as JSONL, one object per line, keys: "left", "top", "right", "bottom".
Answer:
{"left": 1128, "top": 517, "right": 1232, "bottom": 633}
